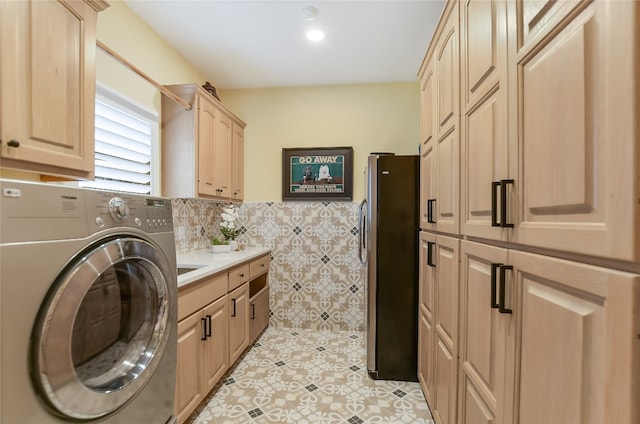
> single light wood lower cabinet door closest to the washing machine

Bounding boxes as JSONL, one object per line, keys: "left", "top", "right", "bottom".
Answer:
{"left": 175, "top": 311, "right": 204, "bottom": 423}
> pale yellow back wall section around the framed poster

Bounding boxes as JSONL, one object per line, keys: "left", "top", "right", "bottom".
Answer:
{"left": 220, "top": 82, "right": 420, "bottom": 202}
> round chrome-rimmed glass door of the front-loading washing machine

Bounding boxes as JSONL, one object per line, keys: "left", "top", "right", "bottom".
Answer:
{"left": 31, "top": 237, "right": 175, "bottom": 420}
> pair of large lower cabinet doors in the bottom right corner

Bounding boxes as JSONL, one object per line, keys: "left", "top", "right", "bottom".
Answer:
{"left": 458, "top": 241, "right": 640, "bottom": 424}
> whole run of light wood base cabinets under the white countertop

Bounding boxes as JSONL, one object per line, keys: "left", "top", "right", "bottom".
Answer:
{"left": 175, "top": 254, "right": 270, "bottom": 423}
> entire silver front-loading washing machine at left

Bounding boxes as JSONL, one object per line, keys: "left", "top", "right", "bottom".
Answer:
{"left": 0, "top": 180, "right": 177, "bottom": 424}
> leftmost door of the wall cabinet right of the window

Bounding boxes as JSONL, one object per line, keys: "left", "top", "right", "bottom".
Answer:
{"left": 196, "top": 96, "right": 219, "bottom": 196}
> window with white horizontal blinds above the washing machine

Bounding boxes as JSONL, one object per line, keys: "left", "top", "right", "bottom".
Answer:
{"left": 80, "top": 85, "right": 158, "bottom": 194}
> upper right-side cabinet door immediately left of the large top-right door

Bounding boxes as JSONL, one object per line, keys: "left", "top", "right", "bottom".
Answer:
{"left": 461, "top": 0, "right": 510, "bottom": 240}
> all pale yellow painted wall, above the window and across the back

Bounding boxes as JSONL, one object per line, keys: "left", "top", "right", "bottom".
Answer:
{"left": 96, "top": 0, "right": 419, "bottom": 202}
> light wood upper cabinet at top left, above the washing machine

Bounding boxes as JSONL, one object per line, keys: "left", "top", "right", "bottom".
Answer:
{"left": 0, "top": 0, "right": 108, "bottom": 179}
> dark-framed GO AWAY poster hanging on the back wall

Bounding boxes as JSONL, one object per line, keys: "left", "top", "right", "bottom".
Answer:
{"left": 282, "top": 147, "right": 353, "bottom": 201}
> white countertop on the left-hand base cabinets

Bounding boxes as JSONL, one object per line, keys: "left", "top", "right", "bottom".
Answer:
{"left": 176, "top": 247, "right": 271, "bottom": 287}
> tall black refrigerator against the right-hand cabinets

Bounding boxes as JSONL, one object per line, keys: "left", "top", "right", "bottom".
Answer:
{"left": 359, "top": 154, "right": 420, "bottom": 381}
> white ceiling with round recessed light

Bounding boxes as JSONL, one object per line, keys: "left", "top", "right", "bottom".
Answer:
{"left": 125, "top": 0, "right": 445, "bottom": 89}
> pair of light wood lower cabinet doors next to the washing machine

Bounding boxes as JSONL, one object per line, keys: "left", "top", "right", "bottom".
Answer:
{"left": 175, "top": 295, "right": 229, "bottom": 423}
